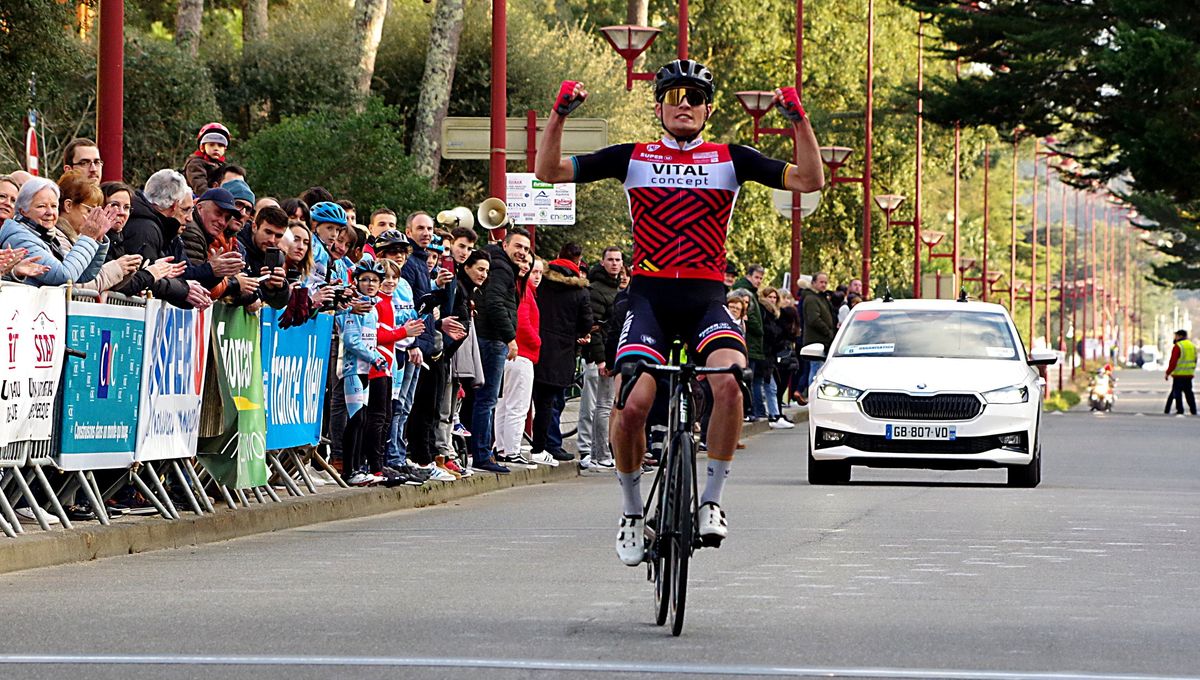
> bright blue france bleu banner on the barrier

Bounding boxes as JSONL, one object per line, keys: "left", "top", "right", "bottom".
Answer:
{"left": 260, "top": 307, "right": 334, "bottom": 450}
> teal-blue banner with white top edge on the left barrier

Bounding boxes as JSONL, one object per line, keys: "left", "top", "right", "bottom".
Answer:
{"left": 55, "top": 301, "right": 146, "bottom": 470}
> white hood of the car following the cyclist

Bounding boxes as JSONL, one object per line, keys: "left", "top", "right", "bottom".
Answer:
{"left": 822, "top": 356, "right": 1032, "bottom": 392}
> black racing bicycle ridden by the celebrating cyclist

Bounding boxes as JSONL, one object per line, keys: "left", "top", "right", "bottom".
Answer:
{"left": 616, "top": 343, "right": 752, "bottom": 637}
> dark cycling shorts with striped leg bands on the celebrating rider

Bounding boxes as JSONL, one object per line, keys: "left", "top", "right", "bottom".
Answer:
{"left": 617, "top": 276, "right": 746, "bottom": 366}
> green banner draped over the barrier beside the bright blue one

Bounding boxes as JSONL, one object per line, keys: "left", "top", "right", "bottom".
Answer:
{"left": 199, "top": 302, "right": 266, "bottom": 488}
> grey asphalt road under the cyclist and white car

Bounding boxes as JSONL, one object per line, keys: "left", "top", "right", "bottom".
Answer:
{"left": 0, "top": 377, "right": 1200, "bottom": 680}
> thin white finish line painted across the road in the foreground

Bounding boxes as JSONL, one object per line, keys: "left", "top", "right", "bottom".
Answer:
{"left": 0, "top": 654, "right": 1200, "bottom": 680}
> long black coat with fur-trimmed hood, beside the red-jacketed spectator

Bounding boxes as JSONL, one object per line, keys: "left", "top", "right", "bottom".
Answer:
{"left": 533, "top": 260, "right": 592, "bottom": 387}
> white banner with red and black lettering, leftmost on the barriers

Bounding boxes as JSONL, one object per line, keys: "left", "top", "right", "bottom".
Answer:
{"left": 0, "top": 284, "right": 67, "bottom": 446}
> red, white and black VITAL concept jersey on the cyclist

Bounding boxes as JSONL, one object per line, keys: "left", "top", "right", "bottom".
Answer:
{"left": 571, "top": 139, "right": 788, "bottom": 281}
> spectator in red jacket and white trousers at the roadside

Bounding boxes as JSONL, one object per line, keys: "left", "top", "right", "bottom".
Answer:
{"left": 494, "top": 259, "right": 544, "bottom": 465}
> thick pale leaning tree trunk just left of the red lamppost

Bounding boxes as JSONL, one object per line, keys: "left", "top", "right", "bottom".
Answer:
{"left": 413, "top": 0, "right": 463, "bottom": 186}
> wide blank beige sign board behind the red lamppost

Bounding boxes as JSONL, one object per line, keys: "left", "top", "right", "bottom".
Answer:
{"left": 442, "top": 116, "right": 608, "bottom": 161}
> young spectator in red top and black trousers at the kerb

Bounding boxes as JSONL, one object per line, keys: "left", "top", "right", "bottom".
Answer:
{"left": 364, "top": 260, "right": 425, "bottom": 483}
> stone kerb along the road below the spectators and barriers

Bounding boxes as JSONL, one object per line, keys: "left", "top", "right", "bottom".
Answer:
{"left": 0, "top": 464, "right": 580, "bottom": 573}
